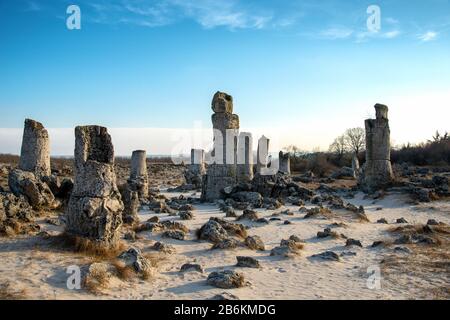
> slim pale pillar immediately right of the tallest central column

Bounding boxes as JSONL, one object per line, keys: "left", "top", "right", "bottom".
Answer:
{"left": 237, "top": 132, "right": 253, "bottom": 183}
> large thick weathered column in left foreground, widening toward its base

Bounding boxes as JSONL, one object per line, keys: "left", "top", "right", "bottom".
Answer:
{"left": 66, "top": 126, "right": 124, "bottom": 246}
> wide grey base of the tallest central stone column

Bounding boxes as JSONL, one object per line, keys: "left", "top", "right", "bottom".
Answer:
{"left": 202, "top": 164, "right": 237, "bottom": 202}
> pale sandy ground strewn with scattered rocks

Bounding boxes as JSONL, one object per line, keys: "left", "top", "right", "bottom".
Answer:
{"left": 0, "top": 188, "right": 450, "bottom": 299}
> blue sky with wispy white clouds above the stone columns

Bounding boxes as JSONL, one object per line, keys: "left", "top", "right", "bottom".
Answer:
{"left": 0, "top": 0, "right": 450, "bottom": 152}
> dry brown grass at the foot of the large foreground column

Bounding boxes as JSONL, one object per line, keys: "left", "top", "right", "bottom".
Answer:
{"left": 50, "top": 232, "right": 126, "bottom": 259}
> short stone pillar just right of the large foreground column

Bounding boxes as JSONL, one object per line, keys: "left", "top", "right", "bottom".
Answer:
{"left": 128, "top": 150, "right": 148, "bottom": 200}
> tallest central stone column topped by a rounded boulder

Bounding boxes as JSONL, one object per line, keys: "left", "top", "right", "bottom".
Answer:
{"left": 202, "top": 92, "right": 239, "bottom": 201}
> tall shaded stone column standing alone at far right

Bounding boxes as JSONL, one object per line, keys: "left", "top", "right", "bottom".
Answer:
{"left": 362, "top": 104, "right": 394, "bottom": 191}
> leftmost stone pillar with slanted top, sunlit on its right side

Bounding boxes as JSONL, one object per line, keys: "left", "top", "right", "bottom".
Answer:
{"left": 19, "top": 119, "right": 51, "bottom": 179}
